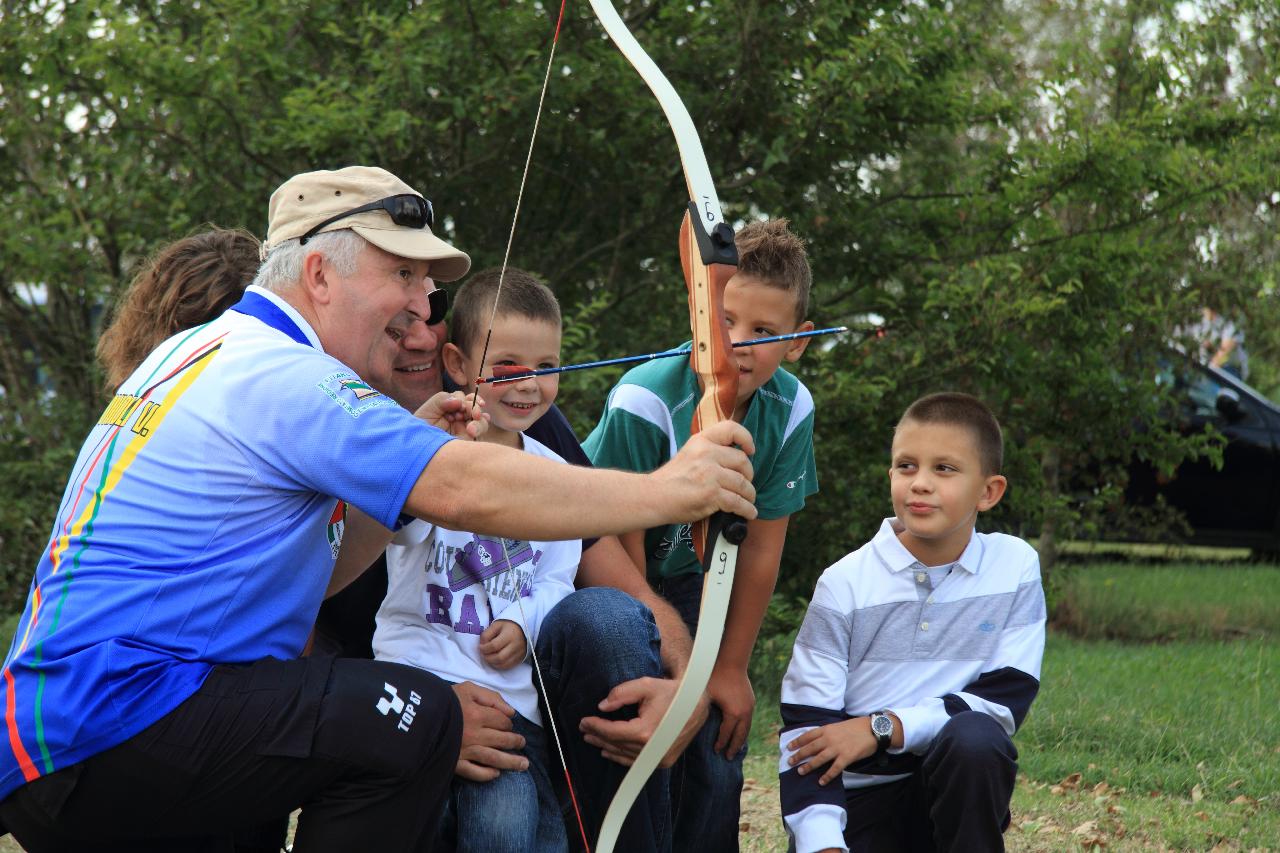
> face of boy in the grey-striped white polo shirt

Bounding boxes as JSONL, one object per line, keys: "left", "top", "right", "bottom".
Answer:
{"left": 888, "top": 420, "right": 1006, "bottom": 566}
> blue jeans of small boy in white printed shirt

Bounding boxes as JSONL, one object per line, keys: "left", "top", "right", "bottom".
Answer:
{"left": 440, "top": 713, "right": 567, "bottom": 853}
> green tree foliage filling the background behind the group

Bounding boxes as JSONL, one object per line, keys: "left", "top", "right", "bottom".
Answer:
{"left": 0, "top": 0, "right": 1280, "bottom": 596}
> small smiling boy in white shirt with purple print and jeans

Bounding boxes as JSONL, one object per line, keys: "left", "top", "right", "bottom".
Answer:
{"left": 374, "top": 268, "right": 581, "bottom": 853}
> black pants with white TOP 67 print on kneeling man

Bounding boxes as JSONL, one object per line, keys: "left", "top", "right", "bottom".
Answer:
{"left": 0, "top": 657, "right": 462, "bottom": 853}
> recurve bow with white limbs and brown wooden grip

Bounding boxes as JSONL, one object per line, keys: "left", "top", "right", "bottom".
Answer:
{"left": 590, "top": 0, "right": 746, "bottom": 853}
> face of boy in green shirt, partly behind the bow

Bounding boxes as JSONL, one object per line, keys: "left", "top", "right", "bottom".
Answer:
{"left": 724, "top": 273, "right": 813, "bottom": 420}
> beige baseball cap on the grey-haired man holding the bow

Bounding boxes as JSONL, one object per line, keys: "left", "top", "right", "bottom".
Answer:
{"left": 262, "top": 167, "right": 471, "bottom": 282}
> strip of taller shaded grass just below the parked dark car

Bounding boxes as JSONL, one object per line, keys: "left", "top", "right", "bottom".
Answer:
{"left": 1053, "top": 562, "right": 1280, "bottom": 640}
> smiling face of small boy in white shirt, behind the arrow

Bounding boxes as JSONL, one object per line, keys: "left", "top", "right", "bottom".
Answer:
{"left": 444, "top": 314, "right": 561, "bottom": 447}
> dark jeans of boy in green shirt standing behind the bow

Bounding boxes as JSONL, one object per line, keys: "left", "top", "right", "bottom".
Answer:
{"left": 660, "top": 575, "right": 746, "bottom": 853}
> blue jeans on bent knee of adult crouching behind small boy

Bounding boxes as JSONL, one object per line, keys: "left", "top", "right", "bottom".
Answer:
{"left": 538, "top": 587, "right": 670, "bottom": 853}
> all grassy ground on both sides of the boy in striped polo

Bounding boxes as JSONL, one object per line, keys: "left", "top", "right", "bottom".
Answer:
{"left": 742, "top": 564, "right": 1280, "bottom": 853}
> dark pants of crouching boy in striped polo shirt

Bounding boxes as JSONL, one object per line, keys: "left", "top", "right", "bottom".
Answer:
{"left": 832, "top": 711, "right": 1018, "bottom": 853}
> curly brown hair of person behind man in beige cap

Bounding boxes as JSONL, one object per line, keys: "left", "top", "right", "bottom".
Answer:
{"left": 97, "top": 227, "right": 259, "bottom": 392}
